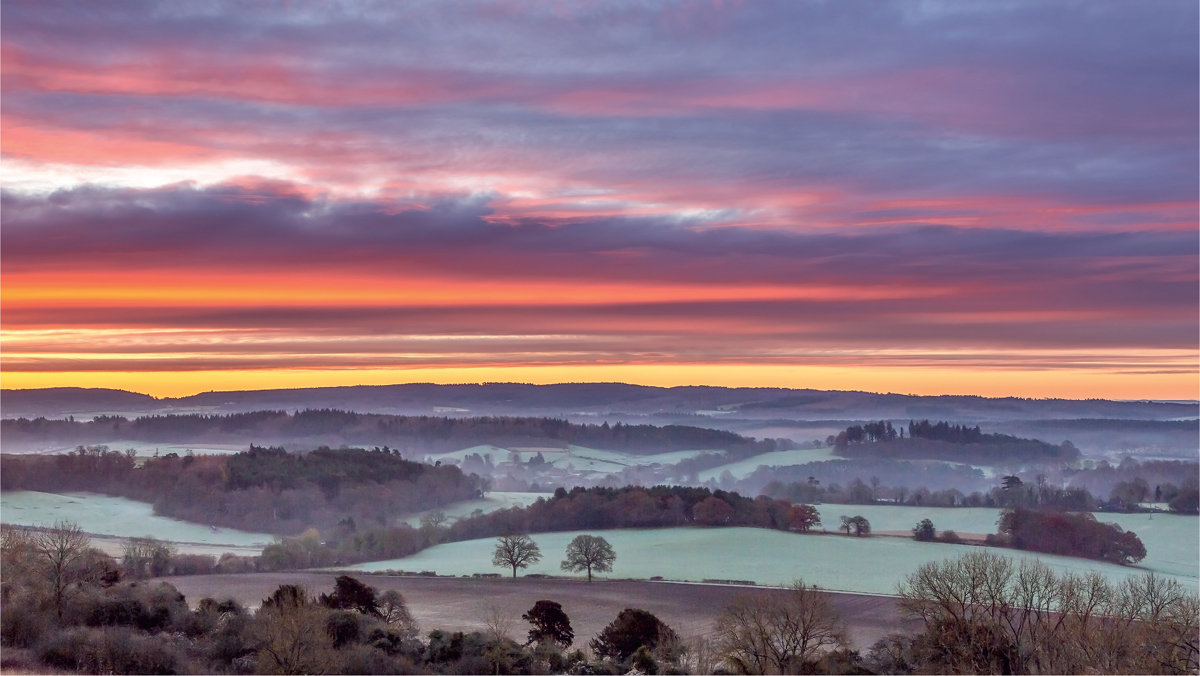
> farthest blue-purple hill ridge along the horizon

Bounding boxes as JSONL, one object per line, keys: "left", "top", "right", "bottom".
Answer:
{"left": 0, "top": 383, "right": 1200, "bottom": 426}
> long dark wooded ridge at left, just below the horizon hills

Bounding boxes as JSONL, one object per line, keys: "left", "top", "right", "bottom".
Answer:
{"left": 0, "top": 408, "right": 796, "bottom": 457}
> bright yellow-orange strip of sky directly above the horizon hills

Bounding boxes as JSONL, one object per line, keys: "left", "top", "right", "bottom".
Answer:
{"left": 0, "top": 364, "right": 1200, "bottom": 401}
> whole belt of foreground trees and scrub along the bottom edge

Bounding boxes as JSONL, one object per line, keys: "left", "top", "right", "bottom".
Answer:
{"left": 0, "top": 524, "right": 1200, "bottom": 674}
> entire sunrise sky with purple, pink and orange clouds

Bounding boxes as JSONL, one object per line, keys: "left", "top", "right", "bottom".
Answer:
{"left": 0, "top": 0, "right": 1200, "bottom": 400}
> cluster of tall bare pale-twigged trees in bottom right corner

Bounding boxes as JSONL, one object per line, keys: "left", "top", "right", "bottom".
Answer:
{"left": 888, "top": 551, "right": 1200, "bottom": 674}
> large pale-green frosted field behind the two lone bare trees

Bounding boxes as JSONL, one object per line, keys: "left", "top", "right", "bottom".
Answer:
{"left": 345, "top": 528, "right": 1196, "bottom": 594}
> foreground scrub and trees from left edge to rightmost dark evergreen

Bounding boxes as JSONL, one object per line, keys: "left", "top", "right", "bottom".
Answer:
{"left": 0, "top": 524, "right": 696, "bottom": 674}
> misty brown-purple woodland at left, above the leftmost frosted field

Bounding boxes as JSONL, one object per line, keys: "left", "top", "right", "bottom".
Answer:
{"left": 0, "top": 445, "right": 488, "bottom": 534}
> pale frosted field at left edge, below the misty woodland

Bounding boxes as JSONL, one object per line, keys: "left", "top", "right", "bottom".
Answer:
{"left": 0, "top": 491, "right": 274, "bottom": 548}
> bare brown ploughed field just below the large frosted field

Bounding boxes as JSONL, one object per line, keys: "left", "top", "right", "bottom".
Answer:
{"left": 162, "top": 572, "right": 906, "bottom": 650}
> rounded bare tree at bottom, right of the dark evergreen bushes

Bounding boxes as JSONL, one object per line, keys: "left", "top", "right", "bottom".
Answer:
{"left": 715, "top": 581, "right": 848, "bottom": 674}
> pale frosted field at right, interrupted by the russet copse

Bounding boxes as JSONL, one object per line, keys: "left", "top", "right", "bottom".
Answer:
{"left": 817, "top": 504, "right": 1200, "bottom": 581}
